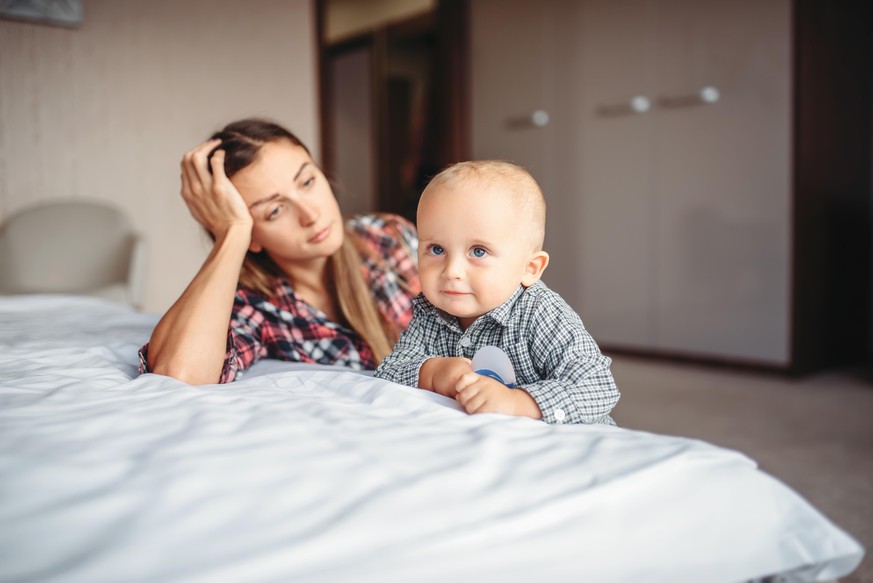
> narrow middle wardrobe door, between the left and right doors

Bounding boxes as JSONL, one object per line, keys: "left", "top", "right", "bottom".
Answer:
{"left": 564, "top": 0, "right": 656, "bottom": 349}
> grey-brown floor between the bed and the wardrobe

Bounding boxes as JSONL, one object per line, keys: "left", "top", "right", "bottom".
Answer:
{"left": 613, "top": 356, "right": 873, "bottom": 583}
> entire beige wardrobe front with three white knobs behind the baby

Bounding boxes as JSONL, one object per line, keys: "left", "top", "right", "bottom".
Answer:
{"left": 471, "top": 0, "right": 792, "bottom": 366}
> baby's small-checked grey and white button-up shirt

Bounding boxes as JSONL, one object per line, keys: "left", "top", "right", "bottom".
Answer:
{"left": 376, "top": 282, "right": 619, "bottom": 425}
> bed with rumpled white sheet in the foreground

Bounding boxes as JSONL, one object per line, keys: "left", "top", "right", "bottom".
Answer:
{"left": 0, "top": 295, "right": 864, "bottom": 583}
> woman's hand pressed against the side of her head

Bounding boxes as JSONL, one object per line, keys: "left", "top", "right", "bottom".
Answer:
{"left": 181, "top": 139, "right": 252, "bottom": 238}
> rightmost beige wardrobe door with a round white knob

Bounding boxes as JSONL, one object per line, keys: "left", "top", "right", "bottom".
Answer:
{"left": 651, "top": 0, "right": 792, "bottom": 365}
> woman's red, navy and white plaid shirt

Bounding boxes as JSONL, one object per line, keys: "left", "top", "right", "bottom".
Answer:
{"left": 140, "top": 214, "right": 421, "bottom": 383}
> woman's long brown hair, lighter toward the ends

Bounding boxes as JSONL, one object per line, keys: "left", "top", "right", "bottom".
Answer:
{"left": 210, "top": 118, "right": 400, "bottom": 363}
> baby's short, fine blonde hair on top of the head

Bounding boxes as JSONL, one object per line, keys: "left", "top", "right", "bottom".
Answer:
{"left": 421, "top": 160, "right": 546, "bottom": 251}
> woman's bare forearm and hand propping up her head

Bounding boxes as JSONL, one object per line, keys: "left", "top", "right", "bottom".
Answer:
{"left": 148, "top": 140, "right": 252, "bottom": 385}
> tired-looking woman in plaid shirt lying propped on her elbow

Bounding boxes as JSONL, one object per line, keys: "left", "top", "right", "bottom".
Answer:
{"left": 140, "top": 119, "right": 420, "bottom": 385}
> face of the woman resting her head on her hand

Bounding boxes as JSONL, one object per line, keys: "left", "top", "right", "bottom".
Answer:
{"left": 231, "top": 140, "right": 343, "bottom": 267}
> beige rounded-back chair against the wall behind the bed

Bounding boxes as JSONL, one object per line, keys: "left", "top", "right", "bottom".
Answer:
{"left": 0, "top": 200, "right": 146, "bottom": 307}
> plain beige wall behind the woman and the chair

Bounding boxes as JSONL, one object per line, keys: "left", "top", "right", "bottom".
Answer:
{"left": 0, "top": 0, "right": 320, "bottom": 312}
